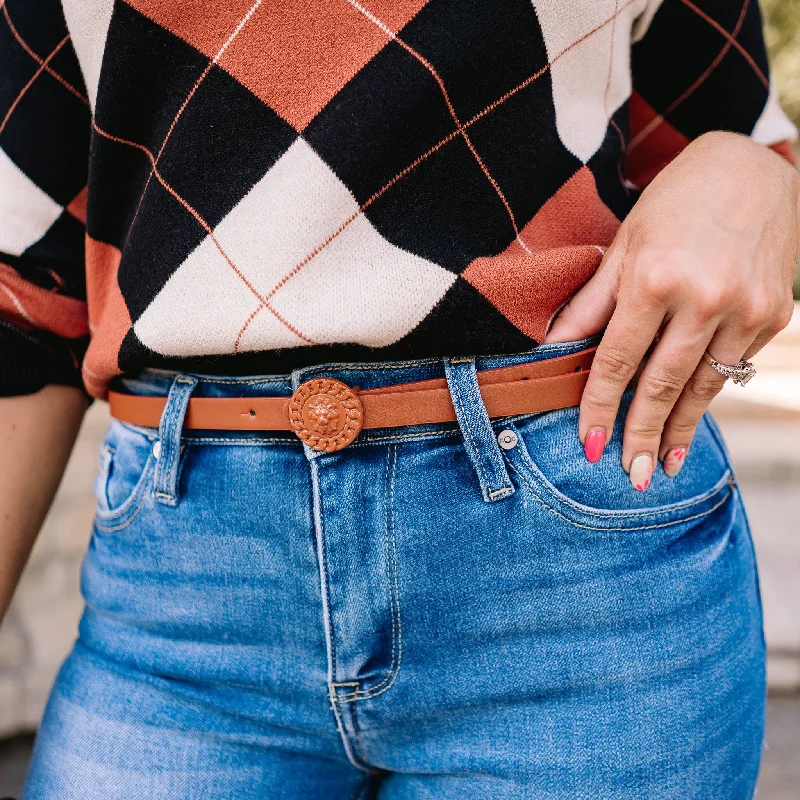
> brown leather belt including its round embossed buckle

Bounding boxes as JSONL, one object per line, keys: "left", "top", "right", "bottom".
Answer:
{"left": 108, "top": 347, "right": 597, "bottom": 452}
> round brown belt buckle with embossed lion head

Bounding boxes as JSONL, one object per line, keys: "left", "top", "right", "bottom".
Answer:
{"left": 289, "top": 378, "right": 364, "bottom": 453}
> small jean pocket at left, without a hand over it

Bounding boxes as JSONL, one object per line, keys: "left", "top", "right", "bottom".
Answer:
{"left": 94, "top": 420, "right": 156, "bottom": 531}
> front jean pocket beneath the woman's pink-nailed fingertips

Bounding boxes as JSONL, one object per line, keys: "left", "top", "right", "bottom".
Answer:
{"left": 504, "top": 394, "right": 735, "bottom": 530}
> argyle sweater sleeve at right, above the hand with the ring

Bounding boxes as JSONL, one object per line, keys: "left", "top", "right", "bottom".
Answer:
{"left": 627, "top": 0, "right": 797, "bottom": 188}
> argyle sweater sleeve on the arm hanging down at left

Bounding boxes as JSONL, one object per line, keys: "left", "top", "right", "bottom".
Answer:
{"left": 0, "top": 0, "right": 91, "bottom": 396}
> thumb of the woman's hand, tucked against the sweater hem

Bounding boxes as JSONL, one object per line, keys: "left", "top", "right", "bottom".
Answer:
{"left": 544, "top": 242, "right": 625, "bottom": 344}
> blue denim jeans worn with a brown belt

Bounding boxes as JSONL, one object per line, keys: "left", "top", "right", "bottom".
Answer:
{"left": 24, "top": 342, "right": 765, "bottom": 800}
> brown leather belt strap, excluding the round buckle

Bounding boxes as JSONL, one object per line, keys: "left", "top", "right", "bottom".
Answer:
{"left": 108, "top": 347, "right": 597, "bottom": 431}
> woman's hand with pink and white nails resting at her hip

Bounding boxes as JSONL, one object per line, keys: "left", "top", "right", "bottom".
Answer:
{"left": 545, "top": 133, "right": 800, "bottom": 491}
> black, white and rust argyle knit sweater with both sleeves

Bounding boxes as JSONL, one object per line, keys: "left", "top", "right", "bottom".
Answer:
{"left": 0, "top": 0, "right": 796, "bottom": 397}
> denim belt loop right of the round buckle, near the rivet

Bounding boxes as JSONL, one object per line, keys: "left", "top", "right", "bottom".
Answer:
{"left": 444, "top": 358, "right": 514, "bottom": 503}
